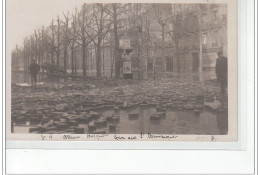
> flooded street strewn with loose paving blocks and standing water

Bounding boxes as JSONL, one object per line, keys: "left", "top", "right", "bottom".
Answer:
{"left": 12, "top": 70, "right": 228, "bottom": 135}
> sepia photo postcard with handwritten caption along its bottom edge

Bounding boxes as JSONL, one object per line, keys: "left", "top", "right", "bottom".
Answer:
{"left": 5, "top": 0, "right": 239, "bottom": 142}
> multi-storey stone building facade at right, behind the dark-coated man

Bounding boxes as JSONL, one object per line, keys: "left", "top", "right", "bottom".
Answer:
{"left": 172, "top": 4, "right": 227, "bottom": 78}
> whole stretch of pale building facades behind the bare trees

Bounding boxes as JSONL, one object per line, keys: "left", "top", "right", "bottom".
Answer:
{"left": 64, "top": 4, "right": 227, "bottom": 79}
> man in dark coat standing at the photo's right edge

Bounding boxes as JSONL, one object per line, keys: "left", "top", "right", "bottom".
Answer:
{"left": 216, "top": 51, "right": 228, "bottom": 94}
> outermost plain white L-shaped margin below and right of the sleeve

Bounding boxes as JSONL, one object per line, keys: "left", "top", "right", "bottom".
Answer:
{"left": 6, "top": 0, "right": 254, "bottom": 174}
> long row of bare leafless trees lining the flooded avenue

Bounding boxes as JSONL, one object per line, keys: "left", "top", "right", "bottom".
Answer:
{"left": 12, "top": 3, "right": 202, "bottom": 77}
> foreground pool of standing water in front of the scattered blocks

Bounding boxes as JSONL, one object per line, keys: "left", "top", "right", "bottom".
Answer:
{"left": 13, "top": 108, "right": 228, "bottom": 135}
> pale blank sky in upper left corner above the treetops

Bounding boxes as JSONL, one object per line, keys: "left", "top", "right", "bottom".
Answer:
{"left": 6, "top": 0, "right": 86, "bottom": 56}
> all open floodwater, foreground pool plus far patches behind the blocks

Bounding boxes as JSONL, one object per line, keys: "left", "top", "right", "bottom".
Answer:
{"left": 12, "top": 70, "right": 225, "bottom": 135}
